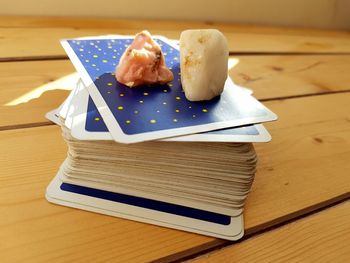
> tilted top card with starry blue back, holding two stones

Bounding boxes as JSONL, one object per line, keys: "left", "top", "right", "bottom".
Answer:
{"left": 62, "top": 36, "right": 277, "bottom": 143}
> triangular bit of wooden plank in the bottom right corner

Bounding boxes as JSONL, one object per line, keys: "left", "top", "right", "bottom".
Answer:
{"left": 191, "top": 202, "right": 350, "bottom": 263}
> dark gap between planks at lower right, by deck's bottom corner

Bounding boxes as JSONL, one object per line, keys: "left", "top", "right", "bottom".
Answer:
{"left": 152, "top": 193, "right": 350, "bottom": 263}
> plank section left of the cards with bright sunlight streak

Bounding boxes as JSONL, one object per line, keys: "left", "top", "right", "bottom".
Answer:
{"left": 0, "top": 60, "right": 77, "bottom": 130}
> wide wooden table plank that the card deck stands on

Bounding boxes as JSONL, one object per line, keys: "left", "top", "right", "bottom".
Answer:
{"left": 0, "top": 93, "right": 350, "bottom": 262}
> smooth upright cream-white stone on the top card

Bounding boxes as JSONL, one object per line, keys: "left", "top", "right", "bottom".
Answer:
{"left": 180, "top": 29, "right": 229, "bottom": 101}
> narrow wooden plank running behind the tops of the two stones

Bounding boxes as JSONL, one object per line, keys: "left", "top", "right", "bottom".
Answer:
{"left": 0, "top": 24, "right": 350, "bottom": 60}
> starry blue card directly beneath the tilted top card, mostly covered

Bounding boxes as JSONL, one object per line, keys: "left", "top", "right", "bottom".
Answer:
{"left": 70, "top": 82, "right": 271, "bottom": 142}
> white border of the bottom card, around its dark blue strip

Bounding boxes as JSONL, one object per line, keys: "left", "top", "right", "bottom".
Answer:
{"left": 46, "top": 173, "right": 243, "bottom": 240}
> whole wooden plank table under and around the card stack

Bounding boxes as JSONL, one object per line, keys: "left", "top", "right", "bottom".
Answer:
{"left": 0, "top": 17, "right": 350, "bottom": 262}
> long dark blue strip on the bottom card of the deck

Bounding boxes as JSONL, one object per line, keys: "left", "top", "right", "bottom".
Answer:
{"left": 60, "top": 183, "right": 231, "bottom": 225}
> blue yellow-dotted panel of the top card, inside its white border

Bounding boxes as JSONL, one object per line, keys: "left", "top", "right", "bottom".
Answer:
{"left": 67, "top": 38, "right": 266, "bottom": 135}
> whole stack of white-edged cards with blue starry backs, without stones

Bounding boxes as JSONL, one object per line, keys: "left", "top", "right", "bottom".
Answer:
{"left": 46, "top": 36, "right": 277, "bottom": 240}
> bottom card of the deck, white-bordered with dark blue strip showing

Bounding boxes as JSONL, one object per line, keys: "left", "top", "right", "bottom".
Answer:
{"left": 46, "top": 166, "right": 244, "bottom": 240}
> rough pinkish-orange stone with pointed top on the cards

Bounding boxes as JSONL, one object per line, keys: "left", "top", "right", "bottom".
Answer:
{"left": 115, "top": 31, "right": 174, "bottom": 88}
